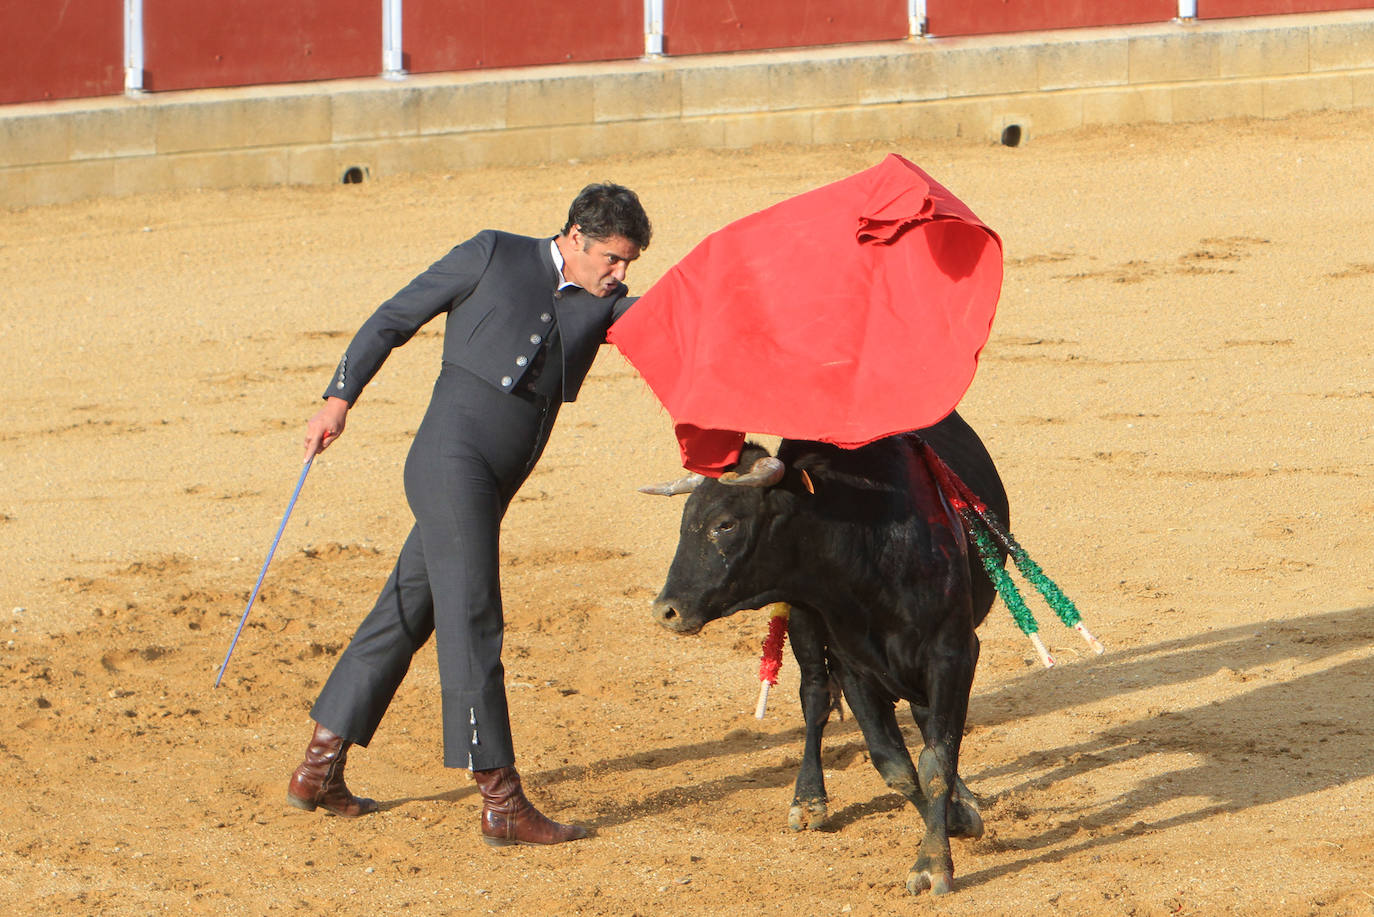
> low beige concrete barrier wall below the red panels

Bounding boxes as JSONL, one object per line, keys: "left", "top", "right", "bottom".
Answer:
{"left": 0, "top": 10, "right": 1374, "bottom": 208}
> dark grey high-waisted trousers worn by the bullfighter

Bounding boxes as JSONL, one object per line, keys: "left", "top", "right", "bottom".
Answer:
{"left": 311, "top": 364, "right": 561, "bottom": 770}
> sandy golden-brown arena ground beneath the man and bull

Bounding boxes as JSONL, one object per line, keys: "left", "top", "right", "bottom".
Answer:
{"left": 0, "top": 111, "right": 1374, "bottom": 917}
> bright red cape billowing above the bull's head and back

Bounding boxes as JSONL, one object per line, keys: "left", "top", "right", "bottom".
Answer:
{"left": 609, "top": 154, "right": 1002, "bottom": 476}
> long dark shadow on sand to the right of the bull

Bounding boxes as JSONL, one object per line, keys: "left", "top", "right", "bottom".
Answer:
{"left": 960, "top": 608, "right": 1374, "bottom": 885}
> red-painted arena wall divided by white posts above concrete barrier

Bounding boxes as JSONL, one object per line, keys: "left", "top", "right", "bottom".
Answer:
{"left": 0, "top": 0, "right": 1374, "bottom": 104}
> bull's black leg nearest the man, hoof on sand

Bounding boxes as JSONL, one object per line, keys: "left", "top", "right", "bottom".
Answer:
{"left": 787, "top": 606, "right": 838, "bottom": 830}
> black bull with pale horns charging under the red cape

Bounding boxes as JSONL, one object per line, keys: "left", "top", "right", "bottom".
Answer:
{"left": 646, "top": 414, "right": 1010, "bottom": 894}
